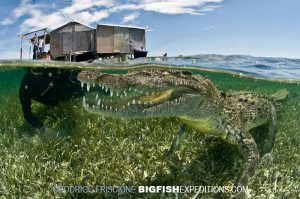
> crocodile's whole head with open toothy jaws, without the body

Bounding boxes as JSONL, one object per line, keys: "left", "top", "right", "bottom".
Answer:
{"left": 78, "top": 69, "right": 218, "bottom": 117}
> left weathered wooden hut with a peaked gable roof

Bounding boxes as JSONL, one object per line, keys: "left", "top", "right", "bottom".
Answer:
{"left": 50, "top": 21, "right": 95, "bottom": 60}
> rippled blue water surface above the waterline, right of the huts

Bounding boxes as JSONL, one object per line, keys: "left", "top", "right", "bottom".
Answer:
{"left": 135, "top": 55, "right": 300, "bottom": 80}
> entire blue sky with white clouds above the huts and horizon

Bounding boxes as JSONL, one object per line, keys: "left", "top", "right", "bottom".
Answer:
{"left": 0, "top": 0, "right": 300, "bottom": 59}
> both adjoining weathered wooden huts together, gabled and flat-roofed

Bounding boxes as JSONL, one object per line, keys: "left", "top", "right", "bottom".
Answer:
{"left": 50, "top": 21, "right": 146, "bottom": 61}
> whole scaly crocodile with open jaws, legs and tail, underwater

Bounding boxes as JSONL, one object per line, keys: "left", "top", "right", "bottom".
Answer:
{"left": 78, "top": 69, "right": 286, "bottom": 196}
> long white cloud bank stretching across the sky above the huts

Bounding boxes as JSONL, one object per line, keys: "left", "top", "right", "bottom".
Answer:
{"left": 0, "top": 0, "right": 224, "bottom": 32}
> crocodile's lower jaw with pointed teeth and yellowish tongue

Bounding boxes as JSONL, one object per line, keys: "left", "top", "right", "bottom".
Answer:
{"left": 82, "top": 84, "right": 202, "bottom": 118}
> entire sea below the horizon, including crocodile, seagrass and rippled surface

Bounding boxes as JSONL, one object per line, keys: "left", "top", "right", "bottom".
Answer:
{"left": 0, "top": 55, "right": 300, "bottom": 198}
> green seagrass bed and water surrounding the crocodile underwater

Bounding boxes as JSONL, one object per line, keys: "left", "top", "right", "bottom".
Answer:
{"left": 0, "top": 67, "right": 300, "bottom": 198}
